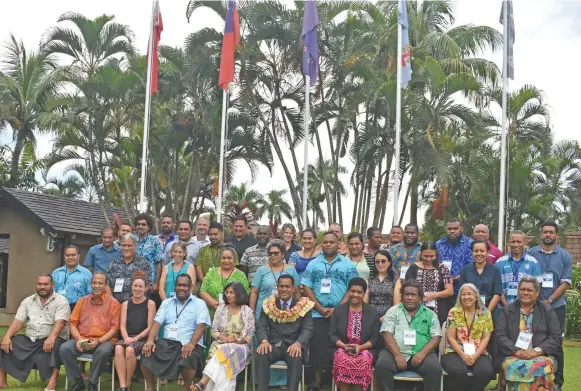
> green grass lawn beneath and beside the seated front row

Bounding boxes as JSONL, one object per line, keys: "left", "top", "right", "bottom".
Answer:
{"left": 0, "top": 327, "right": 581, "bottom": 391}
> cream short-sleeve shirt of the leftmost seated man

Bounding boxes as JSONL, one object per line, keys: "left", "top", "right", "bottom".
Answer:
{"left": 14, "top": 293, "right": 71, "bottom": 339}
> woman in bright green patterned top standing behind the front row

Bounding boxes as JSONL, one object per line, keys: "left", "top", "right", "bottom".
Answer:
{"left": 200, "top": 247, "right": 250, "bottom": 318}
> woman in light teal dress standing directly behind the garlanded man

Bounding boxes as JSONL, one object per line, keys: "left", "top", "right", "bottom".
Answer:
{"left": 250, "top": 240, "right": 301, "bottom": 387}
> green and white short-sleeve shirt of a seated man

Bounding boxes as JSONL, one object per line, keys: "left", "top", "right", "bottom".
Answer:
{"left": 379, "top": 303, "right": 442, "bottom": 361}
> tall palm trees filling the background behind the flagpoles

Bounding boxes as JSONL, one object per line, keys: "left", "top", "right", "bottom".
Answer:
{"left": 0, "top": 0, "right": 581, "bottom": 237}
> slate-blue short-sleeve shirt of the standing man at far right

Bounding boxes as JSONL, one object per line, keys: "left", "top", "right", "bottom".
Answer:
{"left": 529, "top": 246, "right": 573, "bottom": 308}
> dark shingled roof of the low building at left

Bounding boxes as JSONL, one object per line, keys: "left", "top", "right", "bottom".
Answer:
{"left": 0, "top": 188, "right": 129, "bottom": 236}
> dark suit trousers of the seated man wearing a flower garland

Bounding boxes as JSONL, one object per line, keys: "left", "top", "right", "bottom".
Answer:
{"left": 254, "top": 342, "right": 303, "bottom": 391}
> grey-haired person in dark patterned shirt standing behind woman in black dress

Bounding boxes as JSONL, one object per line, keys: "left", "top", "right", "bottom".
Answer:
{"left": 106, "top": 234, "right": 151, "bottom": 303}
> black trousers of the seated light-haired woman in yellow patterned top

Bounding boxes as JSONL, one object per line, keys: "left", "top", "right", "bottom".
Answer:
{"left": 442, "top": 353, "right": 494, "bottom": 391}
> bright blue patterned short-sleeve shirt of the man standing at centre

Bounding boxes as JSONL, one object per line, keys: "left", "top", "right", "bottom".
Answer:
{"left": 301, "top": 253, "right": 358, "bottom": 318}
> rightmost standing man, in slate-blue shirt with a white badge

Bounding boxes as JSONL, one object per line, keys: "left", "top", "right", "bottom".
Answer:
{"left": 529, "top": 221, "right": 573, "bottom": 388}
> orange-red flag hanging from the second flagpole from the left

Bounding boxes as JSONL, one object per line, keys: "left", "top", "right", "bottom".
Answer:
{"left": 218, "top": 0, "right": 240, "bottom": 90}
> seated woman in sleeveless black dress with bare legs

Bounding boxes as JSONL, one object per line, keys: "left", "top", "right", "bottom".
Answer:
{"left": 115, "top": 271, "right": 155, "bottom": 391}
